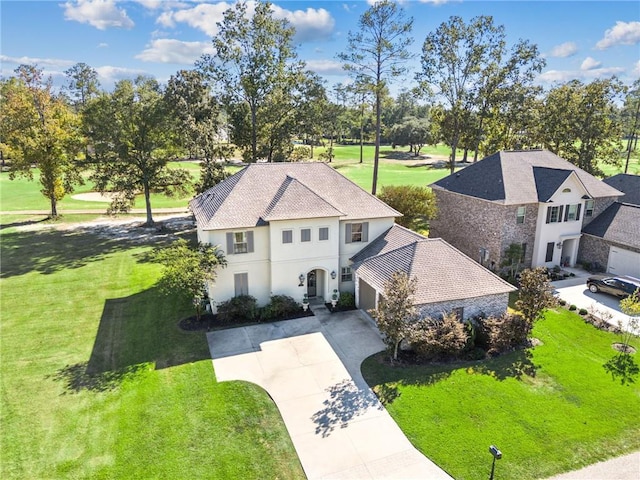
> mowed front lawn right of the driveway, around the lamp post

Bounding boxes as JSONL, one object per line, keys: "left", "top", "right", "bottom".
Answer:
{"left": 362, "top": 310, "right": 640, "bottom": 480}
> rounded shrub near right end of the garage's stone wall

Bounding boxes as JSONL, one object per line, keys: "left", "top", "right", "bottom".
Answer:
{"left": 478, "top": 313, "right": 531, "bottom": 354}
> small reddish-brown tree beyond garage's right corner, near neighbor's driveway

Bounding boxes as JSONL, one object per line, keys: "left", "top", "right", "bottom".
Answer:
{"left": 516, "top": 267, "right": 557, "bottom": 331}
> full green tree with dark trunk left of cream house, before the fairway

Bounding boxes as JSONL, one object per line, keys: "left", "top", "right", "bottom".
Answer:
{"left": 85, "top": 76, "right": 191, "bottom": 225}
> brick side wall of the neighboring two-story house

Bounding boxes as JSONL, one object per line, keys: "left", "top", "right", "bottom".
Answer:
{"left": 429, "top": 188, "right": 538, "bottom": 269}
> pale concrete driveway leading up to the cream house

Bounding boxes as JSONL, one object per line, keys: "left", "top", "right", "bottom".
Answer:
{"left": 207, "top": 307, "right": 451, "bottom": 480}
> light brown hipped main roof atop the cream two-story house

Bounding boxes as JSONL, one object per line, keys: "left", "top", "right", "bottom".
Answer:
{"left": 189, "top": 162, "right": 401, "bottom": 230}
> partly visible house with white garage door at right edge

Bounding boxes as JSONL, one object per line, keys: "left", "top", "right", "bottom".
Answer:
{"left": 579, "top": 174, "right": 640, "bottom": 278}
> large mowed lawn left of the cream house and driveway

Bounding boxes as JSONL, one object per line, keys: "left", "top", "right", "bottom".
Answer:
{"left": 0, "top": 225, "right": 304, "bottom": 479}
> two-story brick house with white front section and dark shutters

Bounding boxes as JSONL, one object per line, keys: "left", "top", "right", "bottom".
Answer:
{"left": 429, "top": 150, "right": 623, "bottom": 270}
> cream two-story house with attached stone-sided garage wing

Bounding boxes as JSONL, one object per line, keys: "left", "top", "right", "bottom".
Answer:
{"left": 190, "top": 163, "right": 514, "bottom": 318}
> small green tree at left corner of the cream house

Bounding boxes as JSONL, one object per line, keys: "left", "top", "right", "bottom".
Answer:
{"left": 153, "top": 238, "right": 227, "bottom": 320}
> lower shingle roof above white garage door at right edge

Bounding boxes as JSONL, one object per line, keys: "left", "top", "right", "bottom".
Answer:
{"left": 582, "top": 202, "right": 640, "bottom": 248}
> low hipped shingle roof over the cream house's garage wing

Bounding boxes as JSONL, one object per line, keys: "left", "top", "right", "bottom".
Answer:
{"left": 354, "top": 227, "right": 516, "bottom": 305}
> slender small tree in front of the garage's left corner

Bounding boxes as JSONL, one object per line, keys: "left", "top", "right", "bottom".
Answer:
{"left": 369, "top": 271, "right": 418, "bottom": 360}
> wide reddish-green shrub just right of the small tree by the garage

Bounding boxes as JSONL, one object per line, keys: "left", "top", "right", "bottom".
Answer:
{"left": 407, "top": 313, "right": 469, "bottom": 360}
